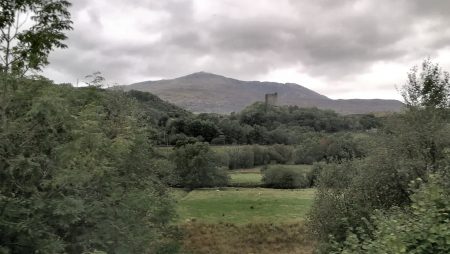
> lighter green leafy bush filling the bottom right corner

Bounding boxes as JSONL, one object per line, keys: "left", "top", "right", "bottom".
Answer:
{"left": 334, "top": 179, "right": 450, "bottom": 254}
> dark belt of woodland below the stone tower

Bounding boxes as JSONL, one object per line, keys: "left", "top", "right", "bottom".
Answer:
{"left": 153, "top": 99, "right": 381, "bottom": 145}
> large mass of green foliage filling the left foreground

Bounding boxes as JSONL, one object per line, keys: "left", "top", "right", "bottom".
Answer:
{"left": 0, "top": 76, "right": 178, "bottom": 253}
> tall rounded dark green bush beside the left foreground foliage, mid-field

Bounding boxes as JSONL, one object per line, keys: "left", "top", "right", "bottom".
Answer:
{"left": 173, "top": 142, "right": 228, "bottom": 189}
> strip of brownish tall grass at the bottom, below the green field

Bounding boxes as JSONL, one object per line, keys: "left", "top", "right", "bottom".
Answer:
{"left": 181, "top": 223, "right": 315, "bottom": 254}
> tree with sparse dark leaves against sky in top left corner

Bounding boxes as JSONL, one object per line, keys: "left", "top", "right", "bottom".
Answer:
{"left": 0, "top": 0, "right": 72, "bottom": 75}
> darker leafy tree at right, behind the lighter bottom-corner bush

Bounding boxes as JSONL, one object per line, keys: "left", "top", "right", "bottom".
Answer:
{"left": 310, "top": 60, "right": 450, "bottom": 253}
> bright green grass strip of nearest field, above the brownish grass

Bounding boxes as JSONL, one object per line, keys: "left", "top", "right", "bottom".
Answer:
{"left": 176, "top": 188, "right": 314, "bottom": 225}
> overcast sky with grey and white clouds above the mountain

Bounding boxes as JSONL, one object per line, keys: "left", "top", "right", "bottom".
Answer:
{"left": 44, "top": 0, "right": 450, "bottom": 98}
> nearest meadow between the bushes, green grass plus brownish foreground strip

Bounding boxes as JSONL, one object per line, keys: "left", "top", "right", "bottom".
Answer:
{"left": 174, "top": 188, "right": 314, "bottom": 254}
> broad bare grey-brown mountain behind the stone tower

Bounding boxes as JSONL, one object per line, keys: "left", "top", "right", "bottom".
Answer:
{"left": 123, "top": 72, "right": 403, "bottom": 114}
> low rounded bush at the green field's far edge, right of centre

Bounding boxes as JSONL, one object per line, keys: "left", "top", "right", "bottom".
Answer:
{"left": 262, "top": 166, "right": 309, "bottom": 189}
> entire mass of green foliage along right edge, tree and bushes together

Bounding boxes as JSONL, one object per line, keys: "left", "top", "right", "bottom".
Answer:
{"left": 310, "top": 61, "right": 450, "bottom": 253}
